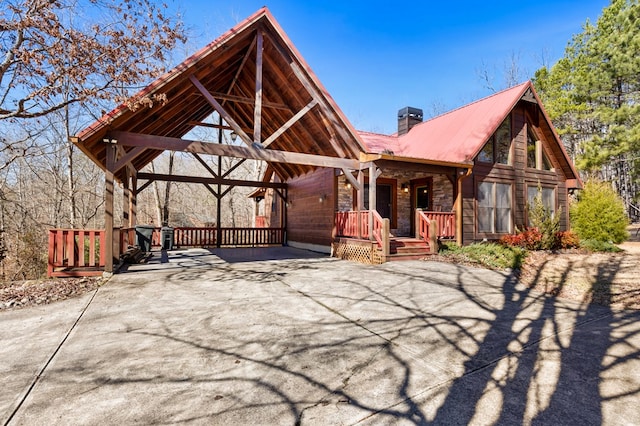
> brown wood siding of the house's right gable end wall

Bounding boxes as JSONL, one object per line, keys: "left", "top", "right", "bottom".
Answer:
{"left": 462, "top": 101, "right": 569, "bottom": 244}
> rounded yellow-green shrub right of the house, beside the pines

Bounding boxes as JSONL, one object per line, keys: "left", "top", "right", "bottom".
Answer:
{"left": 570, "top": 180, "right": 629, "bottom": 244}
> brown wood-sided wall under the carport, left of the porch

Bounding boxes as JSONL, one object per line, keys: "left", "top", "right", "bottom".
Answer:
{"left": 287, "top": 168, "right": 336, "bottom": 247}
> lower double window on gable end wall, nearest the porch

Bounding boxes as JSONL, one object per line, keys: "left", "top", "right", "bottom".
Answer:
{"left": 478, "top": 182, "right": 511, "bottom": 234}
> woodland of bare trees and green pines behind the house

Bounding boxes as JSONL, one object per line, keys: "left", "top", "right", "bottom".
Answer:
{"left": 0, "top": 0, "right": 640, "bottom": 281}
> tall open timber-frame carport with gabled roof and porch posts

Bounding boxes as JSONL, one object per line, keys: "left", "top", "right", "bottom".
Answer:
{"left": 66, "top": 8, "right": 472, "bottom": 273}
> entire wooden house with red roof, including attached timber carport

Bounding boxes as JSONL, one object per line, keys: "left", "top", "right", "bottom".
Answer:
{"left": 65, "top": 8, "right": 578, "bottom": 272}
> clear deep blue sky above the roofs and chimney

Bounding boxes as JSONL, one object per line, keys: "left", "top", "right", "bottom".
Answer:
{"left": 180, "top": 0, "right": 609, "bottom": 133}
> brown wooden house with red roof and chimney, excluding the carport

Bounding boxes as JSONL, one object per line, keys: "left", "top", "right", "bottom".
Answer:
{"left": 258, "top": 82, "right": 580, "bottom": 257}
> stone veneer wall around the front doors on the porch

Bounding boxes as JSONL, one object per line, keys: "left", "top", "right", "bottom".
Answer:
{"left": 338, "top": 171, "right": 453, "bottom": 236}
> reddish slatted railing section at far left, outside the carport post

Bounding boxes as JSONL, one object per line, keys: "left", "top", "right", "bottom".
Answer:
{"left": 47, "top": 229, "right": 106, "bottom": 277}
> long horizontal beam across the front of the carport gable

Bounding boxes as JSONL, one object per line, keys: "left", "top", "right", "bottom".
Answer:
{"left": 111, "top": 132, "right": 368, "bottom": 170}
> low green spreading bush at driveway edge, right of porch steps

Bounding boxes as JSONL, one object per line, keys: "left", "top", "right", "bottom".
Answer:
{"left": 440, "top": 243, "right": 526, "bottom": 269}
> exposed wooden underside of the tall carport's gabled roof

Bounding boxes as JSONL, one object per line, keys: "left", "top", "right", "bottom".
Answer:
{"left": 74, "top": 8, "right": 365, "bottom": 180}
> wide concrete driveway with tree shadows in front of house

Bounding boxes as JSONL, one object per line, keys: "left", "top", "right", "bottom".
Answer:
{"left": 0, "top": 248, "right": 640, "bottom": 425}
